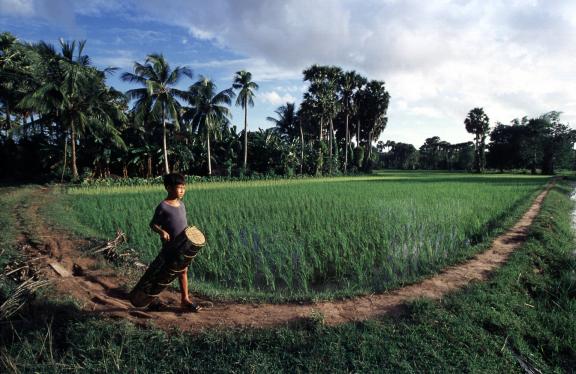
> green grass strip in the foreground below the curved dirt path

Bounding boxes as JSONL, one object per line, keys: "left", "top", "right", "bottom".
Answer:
{"left": 0, "top": 178, "right": 576, "bottom": 373}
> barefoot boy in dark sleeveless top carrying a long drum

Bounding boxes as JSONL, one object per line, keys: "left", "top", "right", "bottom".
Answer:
{"left": 150, "top": 173, "right": 200, "bottom": 312}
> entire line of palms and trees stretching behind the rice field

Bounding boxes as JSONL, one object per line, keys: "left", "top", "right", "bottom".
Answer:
{"left": 0, "top": 33, "right": 573, "bottom": 179}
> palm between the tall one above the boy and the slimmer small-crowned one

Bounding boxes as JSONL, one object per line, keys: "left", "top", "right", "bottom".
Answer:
{"left": 184, "top": 76, "right": 236, "bottom": 175}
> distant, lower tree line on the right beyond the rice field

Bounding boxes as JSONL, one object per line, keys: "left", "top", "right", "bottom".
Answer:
{"left": 377, "top": 108, "right": 576, "bottom": 174}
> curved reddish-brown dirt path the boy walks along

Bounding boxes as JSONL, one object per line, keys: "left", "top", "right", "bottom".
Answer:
{"left": 15, "top": 185, "right": 552, "bottom": 331}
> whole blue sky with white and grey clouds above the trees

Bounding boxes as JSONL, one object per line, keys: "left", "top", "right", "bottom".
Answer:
{"left": 0, "top": 0, "right": 576, "bottom": 147}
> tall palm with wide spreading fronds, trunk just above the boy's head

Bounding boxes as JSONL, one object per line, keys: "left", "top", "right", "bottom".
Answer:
{"left": 122, "top": 54, "right": 192, "bottom": 174}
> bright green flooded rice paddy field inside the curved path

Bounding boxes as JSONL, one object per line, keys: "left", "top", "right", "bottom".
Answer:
{"left": 63, "top": 172, "right": 548, "bottom": 301}
